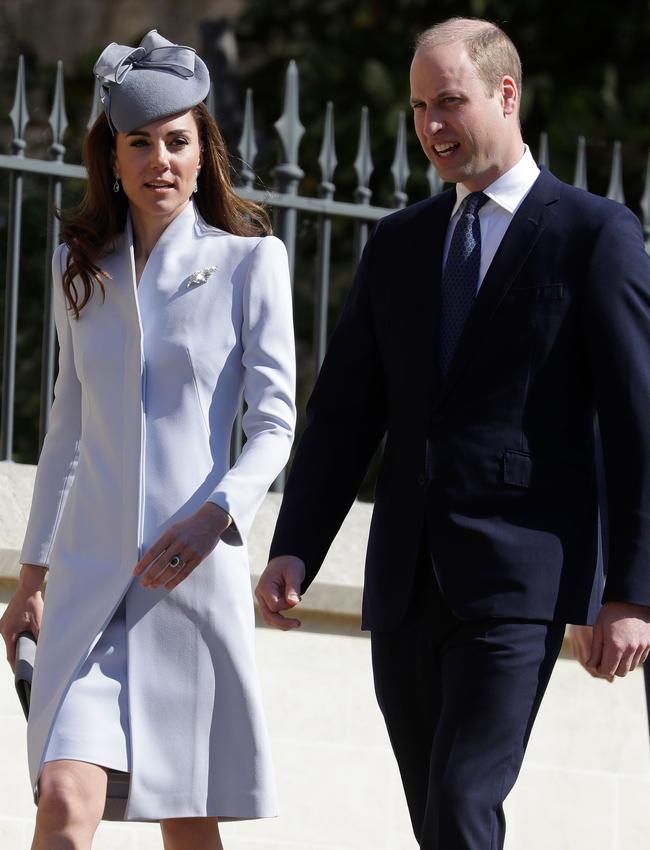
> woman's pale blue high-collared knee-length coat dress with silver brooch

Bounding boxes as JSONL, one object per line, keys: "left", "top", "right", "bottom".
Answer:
{"left": 21, "top": 203, "right": 295, "bottom": 820}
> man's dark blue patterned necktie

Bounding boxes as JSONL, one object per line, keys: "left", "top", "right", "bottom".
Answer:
{"left": 438, "top": 192, "right": 489, "bottom": 376}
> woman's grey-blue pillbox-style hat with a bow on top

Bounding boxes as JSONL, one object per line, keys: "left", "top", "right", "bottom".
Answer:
{"left": 93, "top": 30, "right": 210, "bottom": 133}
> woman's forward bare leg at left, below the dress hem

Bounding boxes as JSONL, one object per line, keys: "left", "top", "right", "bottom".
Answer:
{"left": 32, "top": 759, "right": 107, "bottom": 850}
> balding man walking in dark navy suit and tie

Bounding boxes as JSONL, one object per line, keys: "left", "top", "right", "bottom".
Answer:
{"left": 252, "top": 14, "right": 650, "bottom": 850}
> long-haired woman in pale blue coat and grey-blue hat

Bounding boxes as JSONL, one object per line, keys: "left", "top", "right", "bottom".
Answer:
{"left": 1, "top": 30, "right": 295, "bottom": 850}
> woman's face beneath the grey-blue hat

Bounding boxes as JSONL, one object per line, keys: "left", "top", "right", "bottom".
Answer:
{"left": 113, "top": 110, "right": 201, "bottom": 225}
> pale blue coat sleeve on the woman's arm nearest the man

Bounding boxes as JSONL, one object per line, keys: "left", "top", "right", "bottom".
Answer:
{"left": 208, "top": 236, "right": 296, "bottom": 545}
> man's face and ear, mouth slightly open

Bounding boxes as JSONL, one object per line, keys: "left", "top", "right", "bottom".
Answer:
{"left": 411, "top": 42, "right": 523, "bottom": 192}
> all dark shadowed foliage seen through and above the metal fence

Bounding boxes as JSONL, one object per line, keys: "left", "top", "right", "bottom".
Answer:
{"left": 0, "top": 0, "right": 650, "bottom": 470}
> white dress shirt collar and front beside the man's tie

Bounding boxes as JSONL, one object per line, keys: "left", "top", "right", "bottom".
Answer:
{"left": 443, "top": 145, "right": 539, "bottom": 287}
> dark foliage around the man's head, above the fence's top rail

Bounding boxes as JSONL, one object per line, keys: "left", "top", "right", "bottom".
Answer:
{"left": 238, "top": 0, "right": 650, "bottom": 200}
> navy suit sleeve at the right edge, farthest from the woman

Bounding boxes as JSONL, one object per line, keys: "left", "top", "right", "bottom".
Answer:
{"left": 583, "top": 205, "right": 650, "bottom": 606}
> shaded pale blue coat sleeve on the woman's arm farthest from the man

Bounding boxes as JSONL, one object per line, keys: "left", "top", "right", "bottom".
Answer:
{"left": 20, "top": 245, "right": 81, "bottom": 567}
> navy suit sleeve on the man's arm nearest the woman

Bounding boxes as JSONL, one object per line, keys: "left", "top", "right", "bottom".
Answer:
{"left": 270, "top": 224, "right": 388, "bottom": 590}
